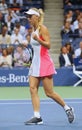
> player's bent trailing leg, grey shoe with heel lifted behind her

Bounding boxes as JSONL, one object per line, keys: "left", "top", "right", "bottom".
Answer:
{"left": 42, "top": 76, "right": 74, "bottom": 123}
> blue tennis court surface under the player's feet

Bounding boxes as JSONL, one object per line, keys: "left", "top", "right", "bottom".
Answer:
{"left": 0, "top": 99, "right": 82, "bottom": 130}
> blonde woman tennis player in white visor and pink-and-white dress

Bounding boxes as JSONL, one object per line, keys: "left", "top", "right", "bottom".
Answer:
{"left": 25, "top": 8, "right": 74, "bottom": 125}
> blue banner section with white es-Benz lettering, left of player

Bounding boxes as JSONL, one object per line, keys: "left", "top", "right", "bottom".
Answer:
{"left": 0, "top": 68, "right": 29, "bottom": 87}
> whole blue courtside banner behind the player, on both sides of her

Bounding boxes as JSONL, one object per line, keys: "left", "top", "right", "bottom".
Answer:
{"left": 0, "top": 67, "right": 82, "bottom": 87}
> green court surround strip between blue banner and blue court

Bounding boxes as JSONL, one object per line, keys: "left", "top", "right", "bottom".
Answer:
{"left": 0, "top": 86, "right": 82, "bottom": 100}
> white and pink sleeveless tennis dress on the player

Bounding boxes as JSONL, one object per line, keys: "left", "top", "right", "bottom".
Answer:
{"left": 29, "top": 29, "right": 56, "bottom": 77}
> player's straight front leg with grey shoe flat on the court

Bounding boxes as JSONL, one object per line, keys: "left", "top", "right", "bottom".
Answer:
{"left": 25, "top": 76, "right": 43, "bottom": 125}
